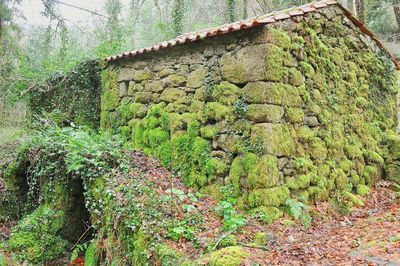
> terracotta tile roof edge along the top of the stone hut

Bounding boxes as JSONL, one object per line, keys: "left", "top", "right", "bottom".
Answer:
{"left": 106, "top": 0, "right": 400, "bottom": 69}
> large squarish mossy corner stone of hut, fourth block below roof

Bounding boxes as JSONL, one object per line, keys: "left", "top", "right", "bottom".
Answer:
{"left": 251, "top": 123, "right": 295, "bottom": 156}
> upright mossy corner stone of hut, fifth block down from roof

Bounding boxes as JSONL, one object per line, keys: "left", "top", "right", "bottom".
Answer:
{"left": 248, "top": 155, "right": 282, "bottom": 188}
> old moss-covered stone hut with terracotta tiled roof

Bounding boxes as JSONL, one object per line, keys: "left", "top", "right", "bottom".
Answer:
{"left": 101, "top": 1, "right": 399, "bottom": 212}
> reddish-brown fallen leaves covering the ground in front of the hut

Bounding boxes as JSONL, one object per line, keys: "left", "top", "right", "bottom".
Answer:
{"left": 0, "top": 152, "right": 400, "bottom": 266}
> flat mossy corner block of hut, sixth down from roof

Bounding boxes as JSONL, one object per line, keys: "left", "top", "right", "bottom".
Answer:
{"left": 249, "top": 186, "right": 290, "bottom": 207}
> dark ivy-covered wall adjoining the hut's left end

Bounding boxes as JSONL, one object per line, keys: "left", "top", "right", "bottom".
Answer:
{"left": 28, "top": 60, "right": 101, "bottom": 129}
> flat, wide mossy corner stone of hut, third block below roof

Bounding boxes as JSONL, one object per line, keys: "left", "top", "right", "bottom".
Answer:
{"left": 244, "top": 104, "right": 284, "bottom": 123}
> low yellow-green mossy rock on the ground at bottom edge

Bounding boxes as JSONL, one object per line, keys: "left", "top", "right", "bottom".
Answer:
{"left": 209, "top": 246, "right": 249, "bottom": 266}
